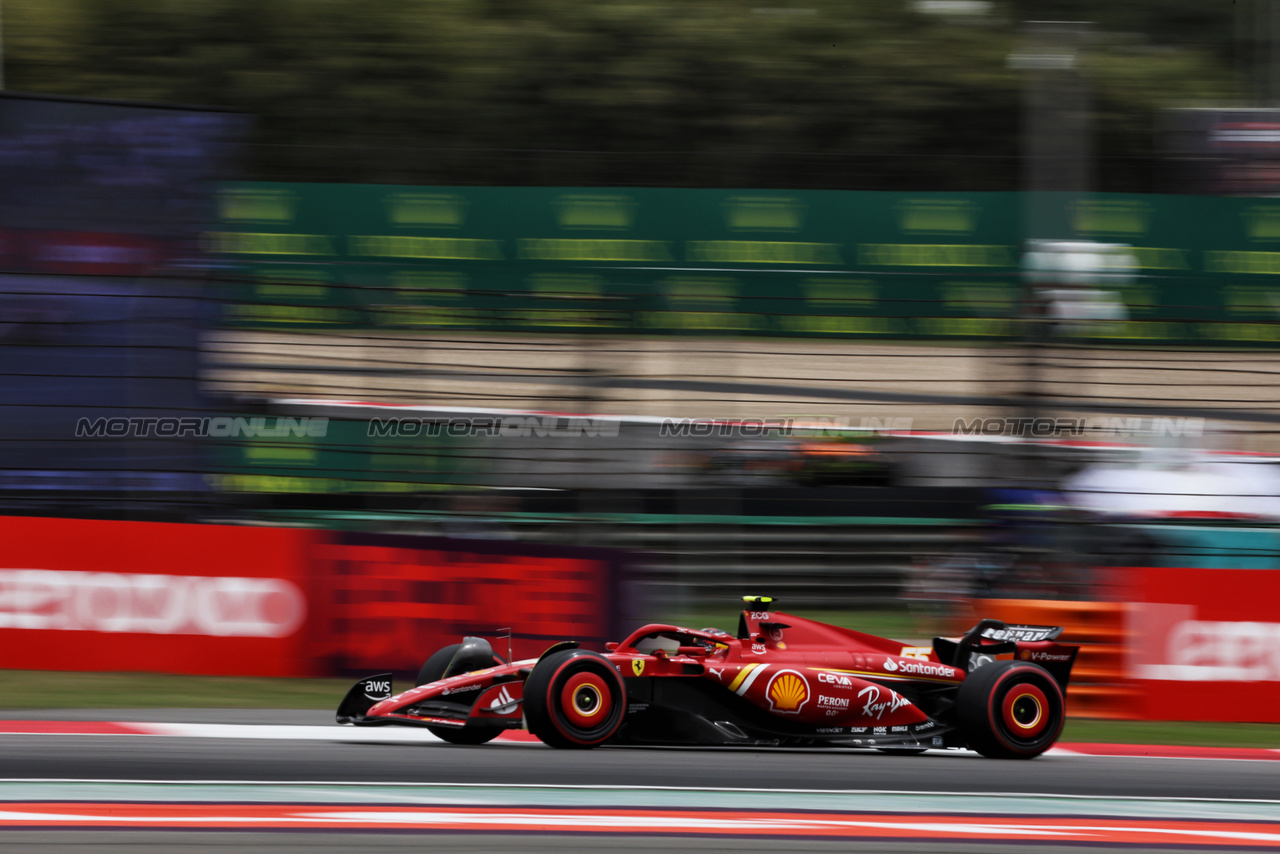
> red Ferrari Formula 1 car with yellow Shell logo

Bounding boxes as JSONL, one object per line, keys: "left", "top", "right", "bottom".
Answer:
{"left": 338, "top": 597, "right": 1079, "bottom": 759}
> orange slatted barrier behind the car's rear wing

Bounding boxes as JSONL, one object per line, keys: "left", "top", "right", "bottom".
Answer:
{"left": 952, "top": 599, "right": 1140, "bottom": 720}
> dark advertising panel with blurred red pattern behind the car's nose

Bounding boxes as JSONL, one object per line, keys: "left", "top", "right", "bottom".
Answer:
{"left": 314, "top": 534, "right": 621, "bottom": 673}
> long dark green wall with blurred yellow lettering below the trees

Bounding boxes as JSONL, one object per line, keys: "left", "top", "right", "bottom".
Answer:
{"left": 202, "top": 183, "right": 1280, "bottom": 344}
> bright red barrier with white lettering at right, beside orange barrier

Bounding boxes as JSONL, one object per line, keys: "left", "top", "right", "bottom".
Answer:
{"left": 1129, "top": 567, "right": 1280, "bottom": 722}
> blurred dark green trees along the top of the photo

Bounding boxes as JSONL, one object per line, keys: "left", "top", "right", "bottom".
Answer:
{"left": 4, "top": 0, "right": 1235, "bottom": 189}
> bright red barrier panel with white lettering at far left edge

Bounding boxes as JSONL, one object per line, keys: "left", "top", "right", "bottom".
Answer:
{"left": 0, "top": 517, "right": 315, "bottom": 676}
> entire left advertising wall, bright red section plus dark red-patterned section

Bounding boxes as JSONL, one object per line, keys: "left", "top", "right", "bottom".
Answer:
{"left": 0, "top": 517, "right": 620, "bottom": 676}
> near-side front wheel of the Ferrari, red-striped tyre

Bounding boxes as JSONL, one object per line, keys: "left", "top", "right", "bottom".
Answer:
{"left": 525, "top": 649, "right": 627, "bottom": 748}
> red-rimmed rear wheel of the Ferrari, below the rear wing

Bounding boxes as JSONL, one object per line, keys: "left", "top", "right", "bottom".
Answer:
{"left": 956, "top": 661, "right": 1066, "bottom": 759}
